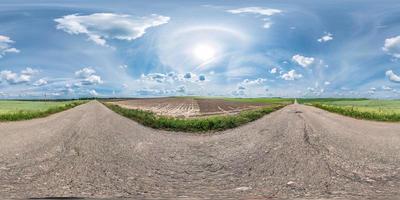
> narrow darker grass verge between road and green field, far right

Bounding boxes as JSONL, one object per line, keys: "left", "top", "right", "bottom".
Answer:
{"left": 308, "top": 103, "right": 400, "bottom": 122}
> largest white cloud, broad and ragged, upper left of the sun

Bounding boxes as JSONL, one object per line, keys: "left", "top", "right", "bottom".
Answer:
{"left": 54, "top": 13, "right": 170, "bottom": 46}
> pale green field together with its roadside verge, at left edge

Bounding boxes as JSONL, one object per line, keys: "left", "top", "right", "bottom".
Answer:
{"left": 0, "top": 100, "right": 88, "bottom": 121}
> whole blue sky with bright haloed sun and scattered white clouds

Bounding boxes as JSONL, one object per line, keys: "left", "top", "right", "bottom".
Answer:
{"left": 0, "top": 0, "right": 400, "bottom": 99}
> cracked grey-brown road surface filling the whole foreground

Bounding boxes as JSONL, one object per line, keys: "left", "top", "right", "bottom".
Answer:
{"left": 0, "top": 101, "right": 400, "bottom": 199}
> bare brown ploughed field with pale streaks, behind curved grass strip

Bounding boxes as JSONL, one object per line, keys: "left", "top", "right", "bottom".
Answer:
{"left": 112, "top": 97, "right": 268, "bottom": 117}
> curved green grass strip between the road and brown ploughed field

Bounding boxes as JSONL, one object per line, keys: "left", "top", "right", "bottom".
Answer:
{"left": 104, "top": 103, "right": 287, "bottom": 132}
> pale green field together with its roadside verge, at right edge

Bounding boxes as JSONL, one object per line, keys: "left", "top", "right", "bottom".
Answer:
{"left": 306, "top": 99, "right": 400, "bottom": 122}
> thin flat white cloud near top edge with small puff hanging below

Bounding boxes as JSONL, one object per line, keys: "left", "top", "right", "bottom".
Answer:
{"left": 227, "top": 7, "right": 282, "bottom": 29}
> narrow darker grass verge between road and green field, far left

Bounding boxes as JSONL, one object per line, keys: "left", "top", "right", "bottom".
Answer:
{"left": 0, "top": 101, "right": 88, "bottom": 121}
